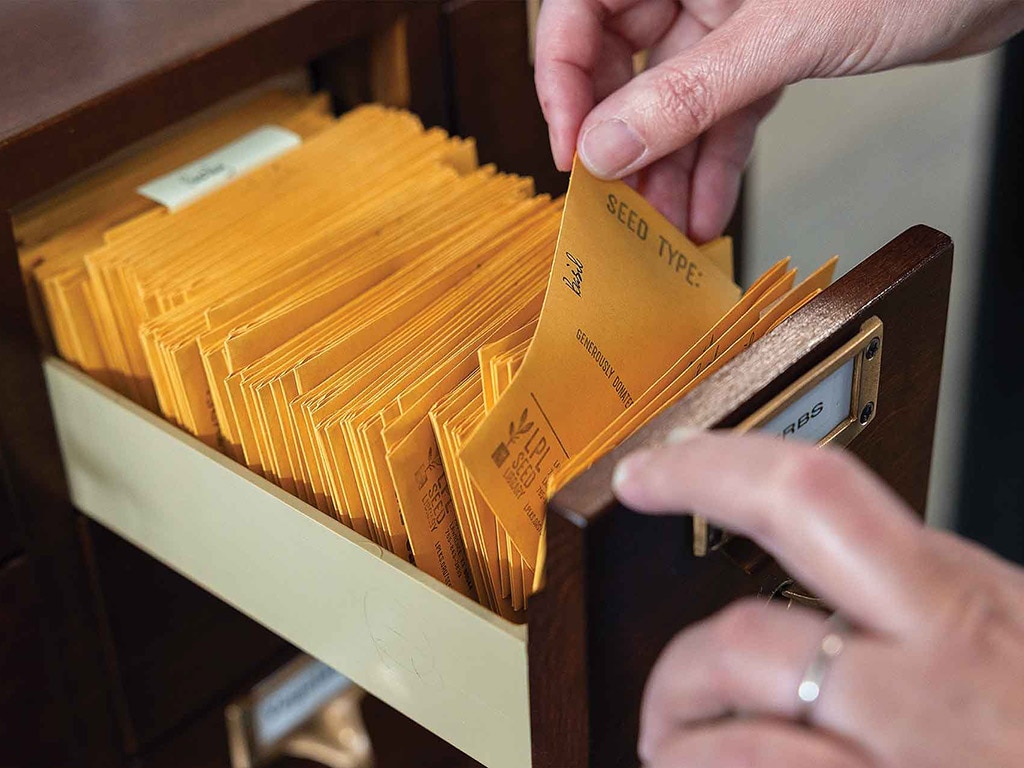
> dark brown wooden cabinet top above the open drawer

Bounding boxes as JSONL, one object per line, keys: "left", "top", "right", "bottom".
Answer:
{"left": 0, "top": 0, "right": 440, "bottom": 207}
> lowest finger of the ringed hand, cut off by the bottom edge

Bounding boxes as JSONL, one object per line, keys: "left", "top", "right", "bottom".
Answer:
{"left": 644, "top": 720, "right": 870, "bottom": 768}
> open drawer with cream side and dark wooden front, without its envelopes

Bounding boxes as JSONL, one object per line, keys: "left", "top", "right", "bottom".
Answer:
{"left": 44, "top": 226, "right": 952, "bottom": 768}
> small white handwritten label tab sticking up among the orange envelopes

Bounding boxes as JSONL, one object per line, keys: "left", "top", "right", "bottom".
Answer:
{"left": 135, "top": 125, "right": 302, "bottom": 212}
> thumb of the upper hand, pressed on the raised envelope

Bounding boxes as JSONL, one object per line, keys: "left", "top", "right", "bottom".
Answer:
{"left": 578, "top": 6, "right": 812, "bottom": 178}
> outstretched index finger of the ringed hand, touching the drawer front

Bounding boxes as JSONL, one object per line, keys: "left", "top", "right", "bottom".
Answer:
{"left": 613, "top": 433, "right": 942, "bottom": 634}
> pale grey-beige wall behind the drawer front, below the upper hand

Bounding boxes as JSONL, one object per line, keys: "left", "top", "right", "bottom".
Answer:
{"left": 744, "top": 53, "right": 999, "bottom": 526}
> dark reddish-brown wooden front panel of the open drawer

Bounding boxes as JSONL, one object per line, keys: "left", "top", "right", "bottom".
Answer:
{"left": 529, "top": 226, "right": 952, "bottom": 768}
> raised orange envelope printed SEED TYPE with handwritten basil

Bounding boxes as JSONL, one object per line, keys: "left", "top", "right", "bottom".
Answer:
{"left": 461, "top": 157, "right": 740, "bottom": 566}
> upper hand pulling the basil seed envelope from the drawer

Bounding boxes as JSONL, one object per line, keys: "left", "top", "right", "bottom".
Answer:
{"left": 535, "top": 0, "right": 1024, "bottom": 242}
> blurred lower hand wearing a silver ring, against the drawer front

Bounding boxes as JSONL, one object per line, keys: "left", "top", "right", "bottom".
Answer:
{"left": 614, "top": 433, "right": 1024, "bottom": 768}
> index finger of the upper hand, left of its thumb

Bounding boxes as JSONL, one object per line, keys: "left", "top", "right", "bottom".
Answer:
{"left": 535, "top": 0, "right": 678, "bottom": 171}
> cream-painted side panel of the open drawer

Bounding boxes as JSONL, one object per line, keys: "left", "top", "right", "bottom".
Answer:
{"left": 44, "top": 359, "right": 530, "bottom": 768}
